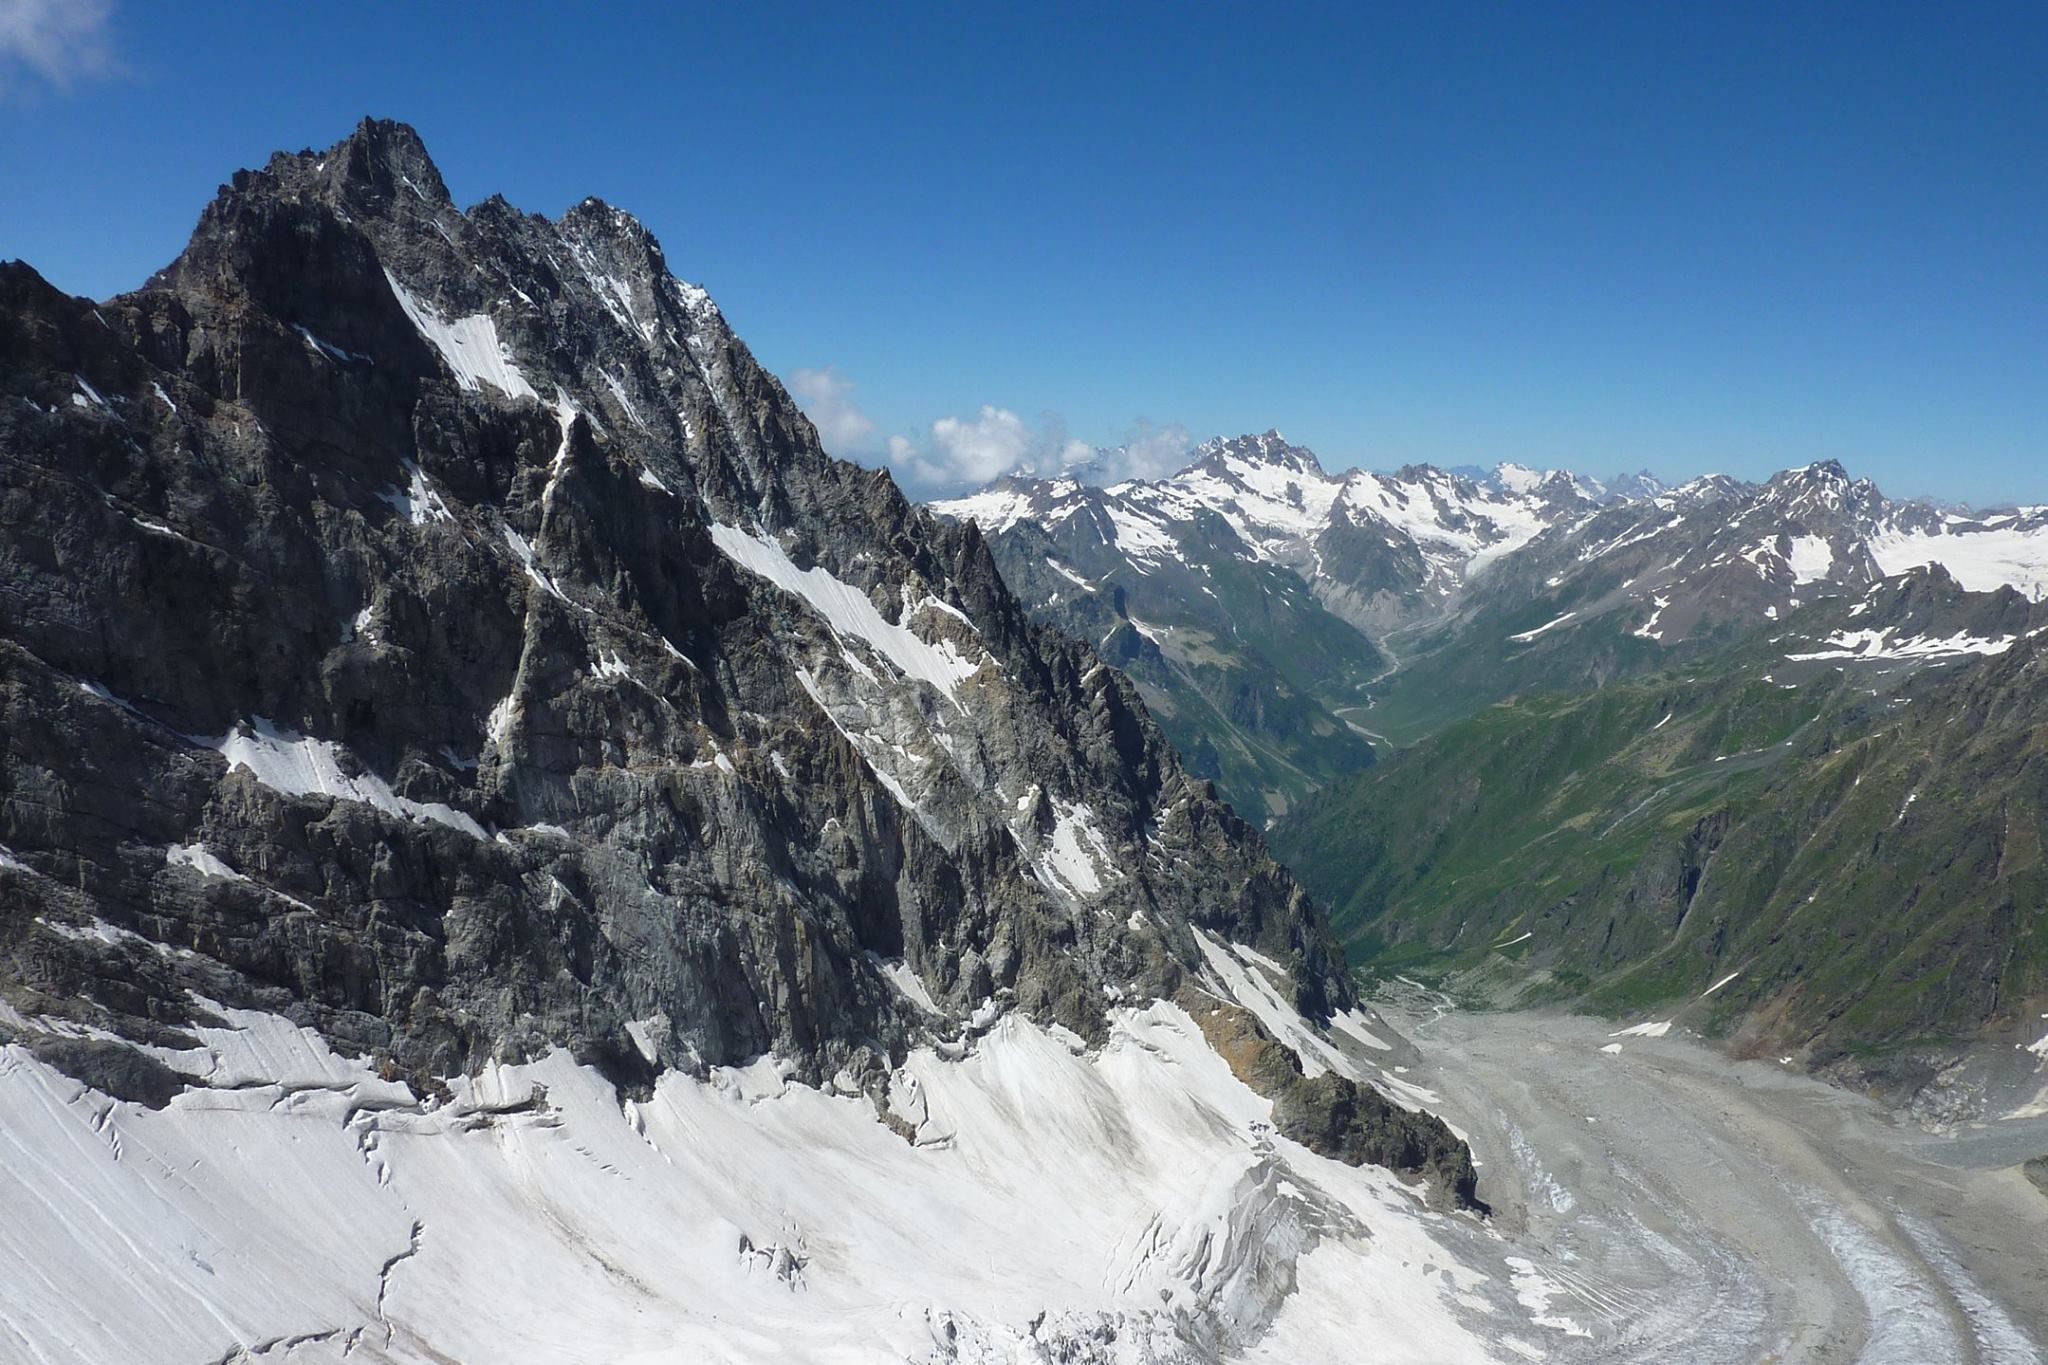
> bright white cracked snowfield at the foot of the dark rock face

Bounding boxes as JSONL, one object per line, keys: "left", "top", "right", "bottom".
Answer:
{"left": 0, "top": 1003, "right": 1530, "bottom": 1365}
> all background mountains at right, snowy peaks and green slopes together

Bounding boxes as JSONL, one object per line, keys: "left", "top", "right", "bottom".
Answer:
{"left": 934, "top": 432, "right": 2048, "bottom": 1091}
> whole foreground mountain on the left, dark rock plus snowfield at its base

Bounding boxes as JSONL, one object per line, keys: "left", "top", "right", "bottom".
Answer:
{"left": 0, "top": 121, "right": 1513, "bottom": 1361}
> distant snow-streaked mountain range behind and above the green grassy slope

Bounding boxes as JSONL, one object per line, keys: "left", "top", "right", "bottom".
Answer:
{"left": 932, "top": 432, "right": 2048, "bottom": 802}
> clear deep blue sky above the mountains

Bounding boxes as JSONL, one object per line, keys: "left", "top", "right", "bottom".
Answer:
{"left": 0, "top": 0, "right": 2048, "bottom": 501}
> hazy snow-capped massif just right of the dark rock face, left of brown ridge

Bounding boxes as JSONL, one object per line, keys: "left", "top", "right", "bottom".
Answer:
{"left": 932, "top": 432, "right": 1610, "bottom": 821}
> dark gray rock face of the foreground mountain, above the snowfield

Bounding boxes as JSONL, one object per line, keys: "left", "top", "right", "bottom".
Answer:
{"left": 0, "top": 121, "right": 1352, "bottom": 1097}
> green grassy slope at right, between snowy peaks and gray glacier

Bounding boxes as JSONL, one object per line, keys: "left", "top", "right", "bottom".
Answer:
{"left": 1274, "top": 639, "right": 2048, "bottom": 1062}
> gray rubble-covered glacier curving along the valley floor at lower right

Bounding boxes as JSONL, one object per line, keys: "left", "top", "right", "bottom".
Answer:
{"left": 1378, "top": 993, "right": 2048, "bottom": 1365}
